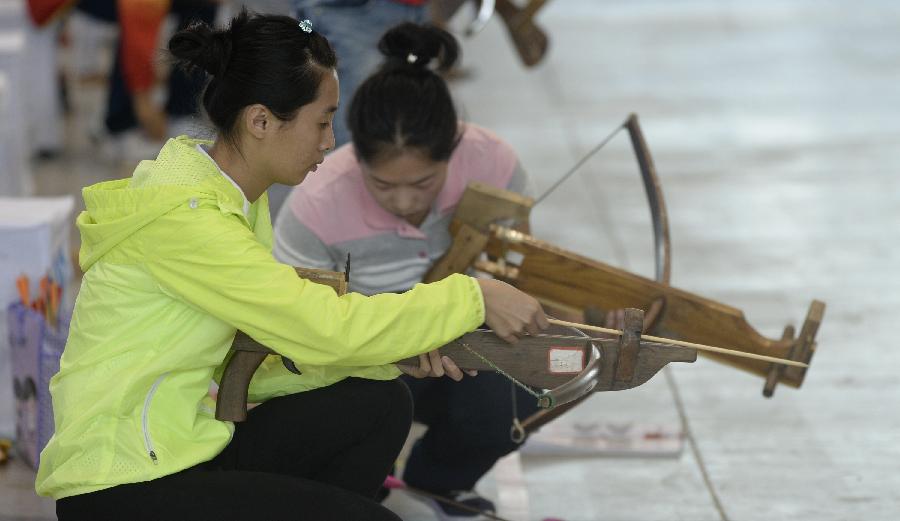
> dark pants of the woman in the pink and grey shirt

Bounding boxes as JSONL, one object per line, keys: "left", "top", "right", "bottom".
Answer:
{"left": 402, "top": 371, "right": 538, "bottom": 493}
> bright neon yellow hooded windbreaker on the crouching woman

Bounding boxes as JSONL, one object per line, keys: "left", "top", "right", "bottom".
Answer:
{"left": 36, "top": 137, "right": 484, "bottom": 499}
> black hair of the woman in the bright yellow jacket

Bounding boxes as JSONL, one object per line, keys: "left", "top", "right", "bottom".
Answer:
{"left": 169, "top": 9, "right": 337, "bottom": 139}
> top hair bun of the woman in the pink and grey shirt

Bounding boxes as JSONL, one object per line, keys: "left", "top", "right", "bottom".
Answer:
{"left": 378, "top": 22, "right": 459, "bottom": 71}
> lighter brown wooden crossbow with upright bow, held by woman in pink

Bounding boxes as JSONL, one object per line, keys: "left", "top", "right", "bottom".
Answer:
{"left": 424, "top": 114, "right": 825, "bottom": 428}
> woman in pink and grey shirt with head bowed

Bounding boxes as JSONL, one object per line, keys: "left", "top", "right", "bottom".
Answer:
{"left": 274, "top": 23, "right": 537, "bottom": 519}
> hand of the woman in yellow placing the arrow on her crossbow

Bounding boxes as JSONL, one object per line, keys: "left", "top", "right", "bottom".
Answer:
{"left": 475, "top": 279, "right": 550, "bottom": 343}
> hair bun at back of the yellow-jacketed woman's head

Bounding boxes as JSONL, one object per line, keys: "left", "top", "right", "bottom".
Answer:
{"left": 169, "top": 23, "right": 234, "bottom": 76}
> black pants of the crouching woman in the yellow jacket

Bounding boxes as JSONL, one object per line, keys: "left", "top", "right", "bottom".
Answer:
{"left": 56, "top": 378, "right": 412, "bottom": 521}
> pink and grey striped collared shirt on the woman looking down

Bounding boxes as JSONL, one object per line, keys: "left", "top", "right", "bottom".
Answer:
{"left": 274, "top": 123, "right": 528, "bottom": 295}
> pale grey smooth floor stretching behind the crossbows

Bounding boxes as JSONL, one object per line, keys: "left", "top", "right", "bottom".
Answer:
{"left": 0, "top": 0, "right": 900, "bottom": 521}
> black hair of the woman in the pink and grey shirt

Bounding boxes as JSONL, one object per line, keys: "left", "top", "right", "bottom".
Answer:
{"left": 347, "top": 23, "right": 460, "bottom": 164}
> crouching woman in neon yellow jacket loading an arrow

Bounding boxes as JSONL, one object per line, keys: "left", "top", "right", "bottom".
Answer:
{"left": 36, "top": 13, "right": 547, "bottom": 521}
